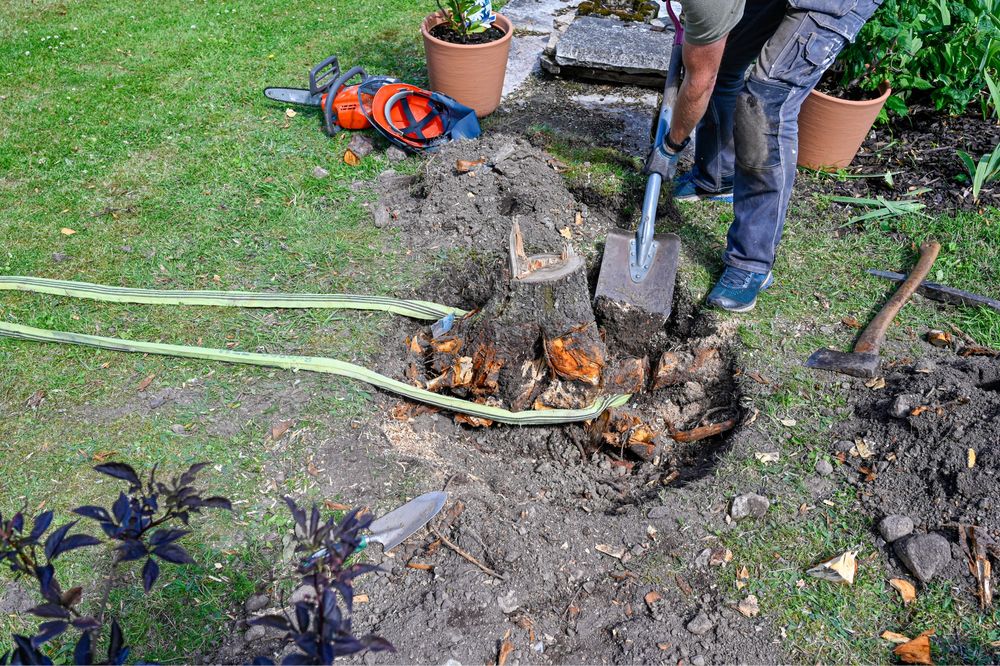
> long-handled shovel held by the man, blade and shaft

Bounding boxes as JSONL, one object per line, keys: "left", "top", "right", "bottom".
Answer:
{"left": 594, "top": 2, "right": 684, "bottom": 320}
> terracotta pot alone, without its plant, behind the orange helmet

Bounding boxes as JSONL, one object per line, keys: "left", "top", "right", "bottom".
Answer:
{"left": 420, "top": 12, "right": 514, "bottom": 118}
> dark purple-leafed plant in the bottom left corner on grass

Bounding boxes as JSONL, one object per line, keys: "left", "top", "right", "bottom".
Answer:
{"left": 0, "top": 463, "right": 232, "bottom": 664}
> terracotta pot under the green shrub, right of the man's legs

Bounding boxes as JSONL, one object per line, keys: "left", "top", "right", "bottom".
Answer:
{"left": 798, "top": 83, "right": 892, "bottom": 169}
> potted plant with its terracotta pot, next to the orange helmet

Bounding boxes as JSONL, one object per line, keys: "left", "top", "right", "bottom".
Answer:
{"left": 420, "top": 0, "right": 514, "bottom": 118}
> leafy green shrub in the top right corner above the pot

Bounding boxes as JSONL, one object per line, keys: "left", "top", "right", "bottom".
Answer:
{"left": 837, "top": 0, "right": 1000, "bottom": 116}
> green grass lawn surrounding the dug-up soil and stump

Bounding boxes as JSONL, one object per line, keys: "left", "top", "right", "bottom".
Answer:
{"left": 0, "top": 0, "right": 1000, "bottom": 663}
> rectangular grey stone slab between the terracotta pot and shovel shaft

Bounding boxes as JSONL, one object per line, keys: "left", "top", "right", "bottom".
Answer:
{"left": 553, "top": 16, "right": 673, "bottom": 77}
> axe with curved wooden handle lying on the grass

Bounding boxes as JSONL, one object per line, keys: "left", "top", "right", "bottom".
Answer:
{"left": 806, "top": 241, "right": 941, "bottom": 377}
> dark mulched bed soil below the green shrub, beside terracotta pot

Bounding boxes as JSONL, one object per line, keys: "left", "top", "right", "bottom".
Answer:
{"left": 821, "top": 107, "right": 1000, "bottom": 215}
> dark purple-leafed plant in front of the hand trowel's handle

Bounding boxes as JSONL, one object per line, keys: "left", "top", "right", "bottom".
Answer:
{"left": 250, "top": 497, "right": 393, "bottom": 664}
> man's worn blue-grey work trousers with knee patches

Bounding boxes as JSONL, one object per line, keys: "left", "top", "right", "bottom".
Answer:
{"left": 694, "top": 0, "right": 882, "bottom": 273}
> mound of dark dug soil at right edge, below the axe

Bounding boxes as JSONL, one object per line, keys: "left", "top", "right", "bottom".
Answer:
{"left": 839, "top": 358, "right": 1000, "bottom": 535}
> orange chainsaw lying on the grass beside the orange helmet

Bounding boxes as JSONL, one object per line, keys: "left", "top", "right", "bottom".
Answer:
{"left": 264, "top": 55, "right": 399, "bottom": 136}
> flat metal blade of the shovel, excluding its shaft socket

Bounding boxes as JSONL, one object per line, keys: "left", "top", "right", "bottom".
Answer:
{"left": 594, "top": 229, "right": 681, "bottom": 321}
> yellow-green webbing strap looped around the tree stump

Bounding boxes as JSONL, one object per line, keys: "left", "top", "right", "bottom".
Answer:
{"left": 0, "top": 276, "right": 631, "bottom": 425}
